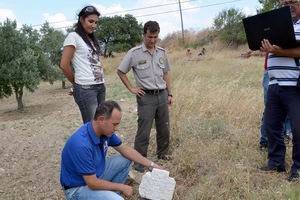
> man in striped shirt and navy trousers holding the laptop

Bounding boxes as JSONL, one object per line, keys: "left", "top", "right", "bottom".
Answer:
{"left": 260, "top": 0, "right": 300, "bottom": 181}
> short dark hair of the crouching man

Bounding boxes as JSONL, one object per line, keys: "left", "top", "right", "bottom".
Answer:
{"left": 94, "top": 101, "right": 122, "bottom": 120}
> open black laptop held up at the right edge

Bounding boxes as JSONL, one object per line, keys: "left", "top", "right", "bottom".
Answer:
{"left": 243, "top": 6, "right": 300, "bottom": 50}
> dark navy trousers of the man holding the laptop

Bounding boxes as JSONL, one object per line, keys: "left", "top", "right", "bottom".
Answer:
{"left": 264, "top": 84, "right": 300, "bottom": 171}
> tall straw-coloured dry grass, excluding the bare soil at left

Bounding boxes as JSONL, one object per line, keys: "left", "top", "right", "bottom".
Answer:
{"left": 102, "top": 44, "right": 300, "bottom": 200}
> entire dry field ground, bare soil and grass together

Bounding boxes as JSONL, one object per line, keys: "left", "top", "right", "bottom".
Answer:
{"left": 0, "top": 45, "right": 300, "bottom": 200}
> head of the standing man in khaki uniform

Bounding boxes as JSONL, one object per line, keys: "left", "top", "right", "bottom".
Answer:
{"left": 144, "top": 21, "right": 160, "bottom": 50}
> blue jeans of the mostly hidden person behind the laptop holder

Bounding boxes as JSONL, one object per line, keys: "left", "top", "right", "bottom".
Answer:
{"left": 259, "top": 70, "right": 292, "bottom": 144}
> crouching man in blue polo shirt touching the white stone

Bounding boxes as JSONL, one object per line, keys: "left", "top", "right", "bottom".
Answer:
{"left": 60, "top": 101, "right": 161, "bottom": 200}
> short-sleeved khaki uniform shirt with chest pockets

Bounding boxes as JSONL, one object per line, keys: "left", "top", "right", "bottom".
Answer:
{"left": 118, "top": 44, "right": 170, "bottom": 90}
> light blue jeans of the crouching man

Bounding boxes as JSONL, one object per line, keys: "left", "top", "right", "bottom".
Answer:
{"left": 64, "top": 155, "right": 131, "bottom": 200}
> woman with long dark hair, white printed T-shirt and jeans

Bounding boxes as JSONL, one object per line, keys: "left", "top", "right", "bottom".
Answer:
{"left": 60, "top": 6, "right": 105, "bottom": 123}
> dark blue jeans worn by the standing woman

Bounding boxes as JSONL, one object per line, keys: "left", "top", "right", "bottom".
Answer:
{"left": 73, "top": 83, "right": 106, "bottom": 123}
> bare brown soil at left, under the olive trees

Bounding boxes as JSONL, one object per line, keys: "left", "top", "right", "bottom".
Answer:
{"left": 0, "top": 83, "right": 81, "bottom": 199}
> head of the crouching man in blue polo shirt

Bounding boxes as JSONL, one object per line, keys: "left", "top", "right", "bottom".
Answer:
{"left": 94, "top": 101, "right": 122, "bottom": 136}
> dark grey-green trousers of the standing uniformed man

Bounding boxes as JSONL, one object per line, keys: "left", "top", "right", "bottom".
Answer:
{"left": 134, "top": 90, "right": 170, "bottom": 157}
